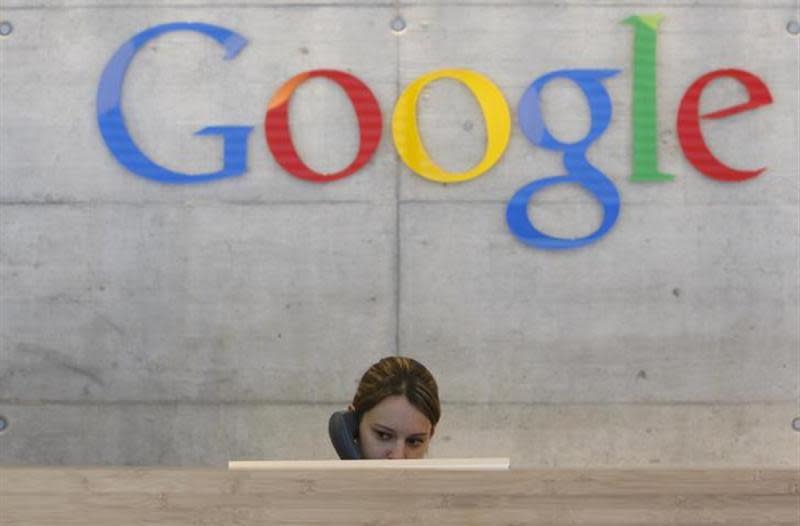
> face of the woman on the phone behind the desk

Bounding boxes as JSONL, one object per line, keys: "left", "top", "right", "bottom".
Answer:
{"left": 358, "top": 395, "right": 433, "bottom": 459}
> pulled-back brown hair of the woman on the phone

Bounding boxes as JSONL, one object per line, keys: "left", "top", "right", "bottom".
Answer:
{"left": 353, "top": 356, "right": 442, "bottom": 427}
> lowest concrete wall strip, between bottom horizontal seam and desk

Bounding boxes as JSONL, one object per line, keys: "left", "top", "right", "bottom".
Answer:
{"left": 0, "top": 402, "right": 797, "bottom": 468}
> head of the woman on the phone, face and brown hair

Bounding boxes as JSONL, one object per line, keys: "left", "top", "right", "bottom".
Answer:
{"left": 348, "top": 356, "right": 441, "bottom": 459}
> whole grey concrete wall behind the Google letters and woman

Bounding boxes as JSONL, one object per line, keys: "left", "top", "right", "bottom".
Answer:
{"left": 0, "top": 0, "right": 800, "bottom": 467}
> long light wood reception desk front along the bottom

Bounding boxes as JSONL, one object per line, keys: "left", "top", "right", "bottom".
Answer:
{"left": 0, "top": 468, "right": 800, "bottom": 526}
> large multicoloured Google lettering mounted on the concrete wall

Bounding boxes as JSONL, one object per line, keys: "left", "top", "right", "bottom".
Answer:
{"left": 97, "top": 15, "right": 772, "bottom": 250}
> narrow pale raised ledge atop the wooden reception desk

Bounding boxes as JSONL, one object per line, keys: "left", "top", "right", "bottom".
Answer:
{"left": 228, "top": 457, "right": 511, "bottom": 471}
